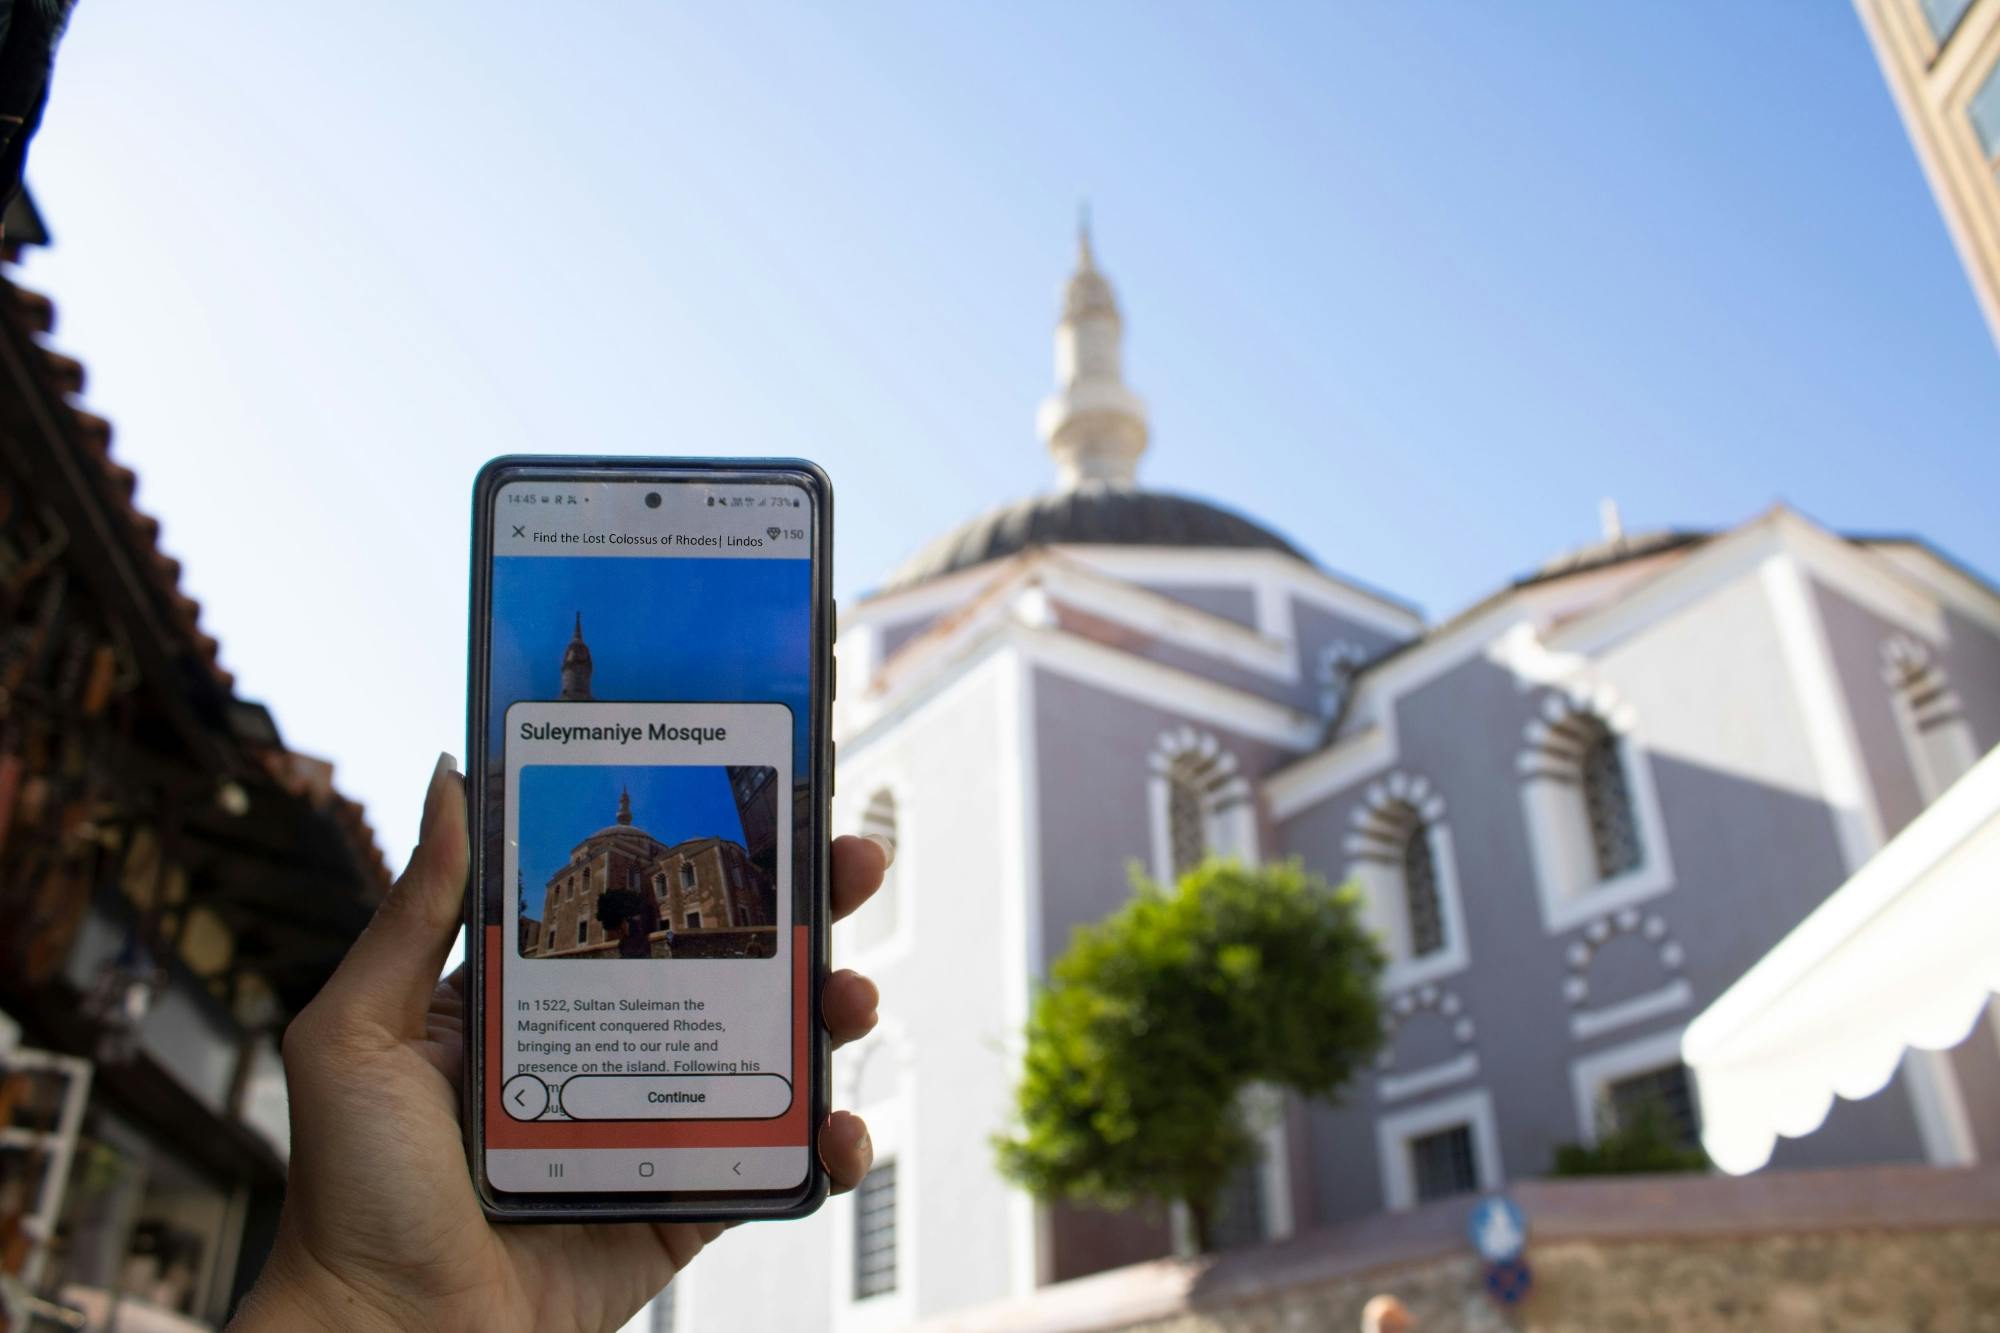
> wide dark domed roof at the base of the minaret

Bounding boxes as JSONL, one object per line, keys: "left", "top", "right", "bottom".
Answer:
{"left": 880, "top": 482, "right": 1312, "bottom": 592}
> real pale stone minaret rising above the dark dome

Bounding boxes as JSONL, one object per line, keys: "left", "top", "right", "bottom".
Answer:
{"left": 1036, "top": 214, "right": 1146, "bottom": 490}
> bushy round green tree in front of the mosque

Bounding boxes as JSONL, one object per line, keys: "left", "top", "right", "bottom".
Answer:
{"left": 998, "top": 861, "right": 1382, "bottom": 1249}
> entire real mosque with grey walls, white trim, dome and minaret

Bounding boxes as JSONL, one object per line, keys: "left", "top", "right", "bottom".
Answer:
{"left": 672, "top": 226, "right": 2000, "bottom": 1329}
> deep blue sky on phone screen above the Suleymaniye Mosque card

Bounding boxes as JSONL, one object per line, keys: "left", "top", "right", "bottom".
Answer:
{"left": 490, "top": 556, "right": 812, "bottom": 756}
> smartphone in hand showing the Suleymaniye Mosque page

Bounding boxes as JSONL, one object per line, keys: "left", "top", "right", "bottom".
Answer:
{"left": 464, "top": 456, "right": 834, "bottom": 1221}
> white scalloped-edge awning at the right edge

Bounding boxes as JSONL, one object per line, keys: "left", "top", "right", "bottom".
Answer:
{"left": 1682, "top": 751, "right": 2000, "bottom": 1175}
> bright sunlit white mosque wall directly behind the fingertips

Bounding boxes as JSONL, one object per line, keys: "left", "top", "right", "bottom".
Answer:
{"left": 680, "top": 650, "right": 1036, "bottom": 1333}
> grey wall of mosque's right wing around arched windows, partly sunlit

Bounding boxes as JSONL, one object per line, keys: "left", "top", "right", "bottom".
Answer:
{"left": 1278, "top": 570, "right": 1918, "bottom": 1221}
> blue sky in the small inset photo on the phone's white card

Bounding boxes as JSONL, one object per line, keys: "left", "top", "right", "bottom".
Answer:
{"left": 520, "top": 765, "right": 752, "bottom": 917}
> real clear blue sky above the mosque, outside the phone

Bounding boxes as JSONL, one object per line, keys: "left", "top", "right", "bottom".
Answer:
{"left": 28, "top": 0, "right": 2000, "bottom": 859}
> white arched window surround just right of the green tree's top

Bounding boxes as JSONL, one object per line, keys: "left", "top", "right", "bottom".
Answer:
{"left": 1342, "top": 769, "right": 1470, "bottom": 991}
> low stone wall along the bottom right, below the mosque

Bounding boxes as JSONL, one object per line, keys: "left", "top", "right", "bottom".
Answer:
{"left": 928, "top": 1167, "right": 2000, "bottom": 1333}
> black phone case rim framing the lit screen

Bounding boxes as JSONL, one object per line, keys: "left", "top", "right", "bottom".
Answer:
{"left": 462, "top": 454, "right": 836, "bottom": 1223}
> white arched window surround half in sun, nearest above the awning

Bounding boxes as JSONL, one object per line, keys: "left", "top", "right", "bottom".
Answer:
{"left": 1514, "top": 685, "right": 1674, "bottom": 935}
